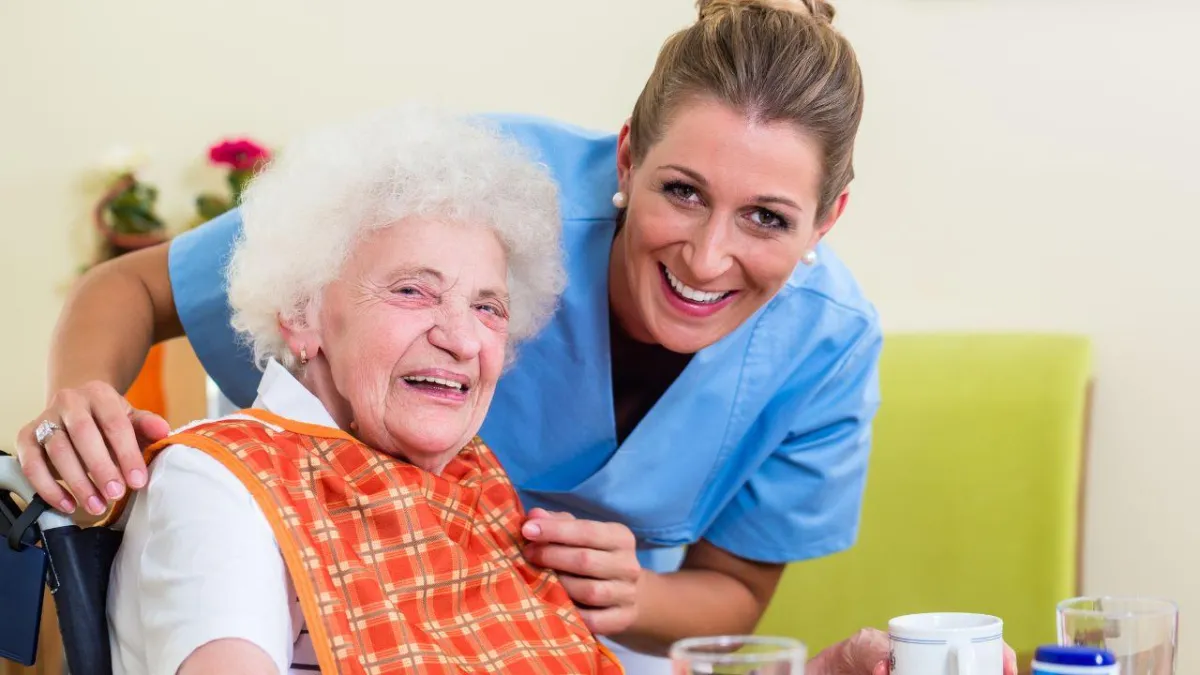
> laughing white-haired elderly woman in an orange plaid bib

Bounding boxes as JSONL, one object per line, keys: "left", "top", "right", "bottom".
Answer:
{"left": 109, "top": 108, "right": 620, "bottom": 675}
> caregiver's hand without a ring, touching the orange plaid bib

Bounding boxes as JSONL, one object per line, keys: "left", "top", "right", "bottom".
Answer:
{"left": 521, "top": 508, "right": 642, "bottom": 635}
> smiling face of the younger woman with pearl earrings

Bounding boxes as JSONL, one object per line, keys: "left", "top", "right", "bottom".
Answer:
{"left": 612, "top": 100, "right": 844, "bottom": 353}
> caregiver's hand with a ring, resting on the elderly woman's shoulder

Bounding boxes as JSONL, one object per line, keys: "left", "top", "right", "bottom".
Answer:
{"left": 17, "top": 382, "right": 170, "bottom": 515}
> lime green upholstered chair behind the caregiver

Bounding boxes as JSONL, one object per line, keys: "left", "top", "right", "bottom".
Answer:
{"left": 758, "top": 334, "right": 1091, "bottom": 667}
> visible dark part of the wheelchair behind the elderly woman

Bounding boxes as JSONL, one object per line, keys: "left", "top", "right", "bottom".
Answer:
{"left": 0, "top": 453, "right": 121, "bottom": 675}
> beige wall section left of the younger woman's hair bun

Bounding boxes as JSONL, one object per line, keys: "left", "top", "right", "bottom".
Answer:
{"left": 0, "top": 0, "right": 692, "bottom": 429}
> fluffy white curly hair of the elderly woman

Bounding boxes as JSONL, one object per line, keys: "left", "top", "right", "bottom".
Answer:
{"left": 227, "top": 104, "right": 565, "bottom": 368}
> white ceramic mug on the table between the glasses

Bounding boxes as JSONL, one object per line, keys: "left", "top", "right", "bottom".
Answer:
{"left": 888, "top": 613, "right": 1004, "bottom": 675}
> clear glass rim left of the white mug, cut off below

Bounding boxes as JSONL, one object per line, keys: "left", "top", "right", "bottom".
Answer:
{"left": 671, "top": 635, "right": 809, "bottom": 675}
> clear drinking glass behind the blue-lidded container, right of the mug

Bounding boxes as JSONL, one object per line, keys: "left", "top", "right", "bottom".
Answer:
{"left": 1058, "top": 598, "right": 1180, "bottom": 675}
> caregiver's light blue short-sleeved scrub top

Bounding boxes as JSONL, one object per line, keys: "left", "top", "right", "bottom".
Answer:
{"left": 169, "top": 115, "right": 881, "bottom": 572}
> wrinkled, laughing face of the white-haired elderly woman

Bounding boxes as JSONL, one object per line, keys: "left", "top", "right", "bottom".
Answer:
{"left": 319, "top": 220, "right": 509, "bottom": 472}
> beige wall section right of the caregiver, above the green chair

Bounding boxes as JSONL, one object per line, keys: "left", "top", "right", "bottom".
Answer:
{"left": 835, "top": 0, "right": 1200, "bottom": 673}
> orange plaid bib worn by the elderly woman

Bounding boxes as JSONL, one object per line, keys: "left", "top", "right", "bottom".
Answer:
{"left": 148, "top": 411, "right": 622, "bottom": 675}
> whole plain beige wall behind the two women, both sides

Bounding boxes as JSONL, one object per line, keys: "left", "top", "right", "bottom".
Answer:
{"left": 0, "top": 0, "right": 1200, "bottom": 673}
